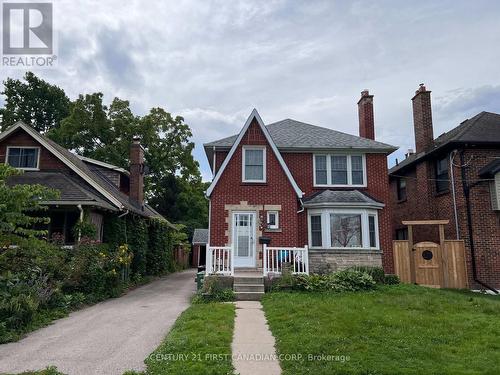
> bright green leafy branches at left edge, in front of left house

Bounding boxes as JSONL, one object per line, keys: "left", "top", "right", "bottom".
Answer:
{"left": 0, "top": 164, "right": 58, "bottom": 247}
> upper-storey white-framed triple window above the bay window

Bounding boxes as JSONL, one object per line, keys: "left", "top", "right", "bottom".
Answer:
{"left": 314, "top": 154, "right": 366, "bottom": 187}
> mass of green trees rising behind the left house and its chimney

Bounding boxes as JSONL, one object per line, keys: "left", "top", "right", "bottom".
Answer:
{"left": 0, "top": 73, "right": 208, "bottom": 239}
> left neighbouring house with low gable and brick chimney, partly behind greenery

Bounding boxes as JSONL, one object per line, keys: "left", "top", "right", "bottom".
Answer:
{"left": 0, "top": 122, "right": 166, "bottom": 244}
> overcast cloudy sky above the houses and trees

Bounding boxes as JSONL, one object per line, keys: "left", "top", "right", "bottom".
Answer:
{"left": 0, "top": 0, "right": 500, "bottom": 180}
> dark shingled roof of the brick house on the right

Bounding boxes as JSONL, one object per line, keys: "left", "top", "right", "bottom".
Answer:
{"left": 389, "top": 111, "right": 500, "bottom": 174}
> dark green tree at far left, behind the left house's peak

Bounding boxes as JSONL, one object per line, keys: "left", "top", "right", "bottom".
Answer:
{"left": 0, "top": 72, "right": 70, "bottom": 133}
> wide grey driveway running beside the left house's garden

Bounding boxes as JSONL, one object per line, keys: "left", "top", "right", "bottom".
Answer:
{"left": 0, "top": 270, "right": 196, "bottom": 375}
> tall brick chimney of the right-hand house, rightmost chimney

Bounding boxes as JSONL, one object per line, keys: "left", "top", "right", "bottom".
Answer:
{"left": 411, "top": 83, "right": 434, "bottom": 153}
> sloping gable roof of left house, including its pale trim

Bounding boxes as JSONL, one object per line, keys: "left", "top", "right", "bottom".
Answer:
{"left": 0, "top": 121, "right": 168, "bottom": 219}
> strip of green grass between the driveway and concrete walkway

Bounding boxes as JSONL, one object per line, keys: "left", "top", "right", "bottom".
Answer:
{"left": 145, "top": 303, "right": 235, "bottom": 375}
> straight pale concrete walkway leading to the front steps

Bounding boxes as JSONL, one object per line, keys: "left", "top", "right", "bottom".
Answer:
{"left": 232, "top": 301, "right": 281, "bottom": 375}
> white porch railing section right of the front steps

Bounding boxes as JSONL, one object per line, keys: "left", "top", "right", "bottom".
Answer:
{"left": 264, "top": 245, "right": 309, "bottom": 276}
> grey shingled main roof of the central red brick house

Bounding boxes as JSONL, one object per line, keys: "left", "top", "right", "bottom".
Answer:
{"left": 205, "top": 119, "right": 397, "bottom": 152}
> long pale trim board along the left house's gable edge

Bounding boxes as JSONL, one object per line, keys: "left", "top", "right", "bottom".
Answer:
{"left": 0, "top": 121, "right": 124, "bottom": 210}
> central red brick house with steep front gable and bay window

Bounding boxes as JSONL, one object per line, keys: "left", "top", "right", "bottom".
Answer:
{"left": 204, "top": 91, "right": 396, "bottom": 272}
